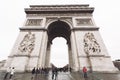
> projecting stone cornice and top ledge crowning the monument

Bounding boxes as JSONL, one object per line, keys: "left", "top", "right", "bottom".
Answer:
{"left": 25, "top": 5, "right": 94, "bottom": 14}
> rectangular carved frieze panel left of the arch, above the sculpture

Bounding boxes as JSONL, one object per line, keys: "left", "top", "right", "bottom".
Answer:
{"left": 25, "top": 19, "right": 42, "bottom": 26}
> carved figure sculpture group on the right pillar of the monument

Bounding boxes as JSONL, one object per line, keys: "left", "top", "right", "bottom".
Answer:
{"left": 84, "top": 32, "right": 101, "bottom": 54}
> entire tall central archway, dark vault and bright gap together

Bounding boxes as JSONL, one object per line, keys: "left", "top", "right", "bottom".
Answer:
{"left": 47, "top": 20, "right": 71, "bottom": 67}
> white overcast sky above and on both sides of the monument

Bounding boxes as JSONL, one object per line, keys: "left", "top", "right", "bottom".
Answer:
{"left": 0, "top": 0, "right": 120, "bottom": 66}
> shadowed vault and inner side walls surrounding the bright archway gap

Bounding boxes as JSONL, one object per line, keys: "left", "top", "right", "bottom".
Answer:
{"left": 45, "top": 20, "right": 72, "bottom": 67}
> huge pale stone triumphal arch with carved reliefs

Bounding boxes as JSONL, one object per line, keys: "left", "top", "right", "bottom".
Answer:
{"left": 3, "top": 5, "right": 117, "bottom": 72}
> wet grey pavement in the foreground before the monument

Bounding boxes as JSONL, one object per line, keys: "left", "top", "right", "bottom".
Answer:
{"left": 0, "top": 72, "right": 120, "bottom": 80}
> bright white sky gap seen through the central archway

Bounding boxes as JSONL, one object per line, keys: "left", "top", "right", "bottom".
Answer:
{"left": 50, "top": 37, "right": 69, "bottom": 67}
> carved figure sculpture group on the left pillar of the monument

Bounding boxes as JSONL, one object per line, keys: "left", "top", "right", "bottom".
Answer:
{"left": 18, "top": 32, "right": 35, "bottom": 53}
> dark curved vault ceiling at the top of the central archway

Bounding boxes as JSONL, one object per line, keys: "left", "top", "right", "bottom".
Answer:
{"left": 47, "top": 20, "right": 71, "bottom": 43}
